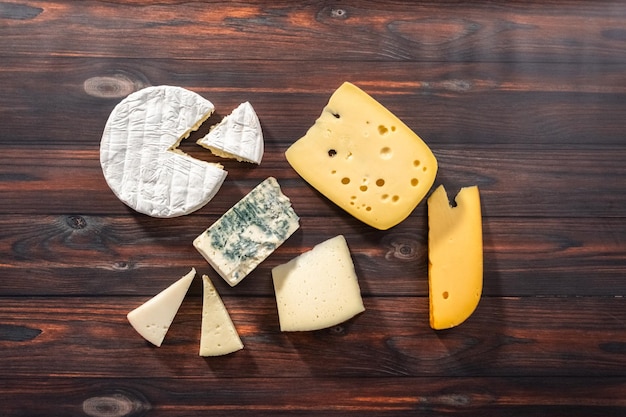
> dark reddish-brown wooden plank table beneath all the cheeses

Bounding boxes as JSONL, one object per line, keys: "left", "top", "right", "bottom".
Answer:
{"left": 0, "top": 0, "right": 626, "bottom": 417}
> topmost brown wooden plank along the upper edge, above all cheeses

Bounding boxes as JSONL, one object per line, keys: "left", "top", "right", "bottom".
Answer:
{"left": 0, "top": 1, "right": 626, "bottom": 63}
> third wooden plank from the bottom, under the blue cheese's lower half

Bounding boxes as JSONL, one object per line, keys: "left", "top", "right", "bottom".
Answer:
{"left": 0, "top": 215, "right": 626, "bottom": 297}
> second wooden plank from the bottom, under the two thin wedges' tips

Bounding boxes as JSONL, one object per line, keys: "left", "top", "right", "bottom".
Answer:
{"left": 0, "top": 293, "right": 626, "bottom": 378}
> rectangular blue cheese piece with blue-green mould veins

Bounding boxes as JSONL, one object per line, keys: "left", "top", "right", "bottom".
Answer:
{"left": 193, "top": 177, "right": 300, "bottom": 286}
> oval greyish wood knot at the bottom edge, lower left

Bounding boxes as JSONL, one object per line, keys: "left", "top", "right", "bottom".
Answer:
{"left": 83, "top": 392, "right": 150, "bottom": 417}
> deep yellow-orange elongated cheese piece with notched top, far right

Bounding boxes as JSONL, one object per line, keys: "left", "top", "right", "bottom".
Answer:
{"left": 428, "top": 185, "right": 483, "bottom": 329}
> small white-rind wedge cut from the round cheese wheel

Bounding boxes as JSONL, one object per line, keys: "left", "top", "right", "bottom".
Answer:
{"left": 196, "top": 101, "right": 264, "bottom": 164}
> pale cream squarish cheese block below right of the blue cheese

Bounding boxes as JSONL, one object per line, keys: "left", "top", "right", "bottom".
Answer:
{"left": 272, "top": 235, "right": 365, "bottom": 331}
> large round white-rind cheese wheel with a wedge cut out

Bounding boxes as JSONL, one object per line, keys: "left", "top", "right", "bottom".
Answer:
{"left": 100, "top": 85, "right": 226, "bottom": 217}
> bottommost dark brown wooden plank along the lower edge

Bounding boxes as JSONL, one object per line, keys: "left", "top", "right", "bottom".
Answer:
{"left": 0, "top": 377, "right": 626, "bottom": 417}
